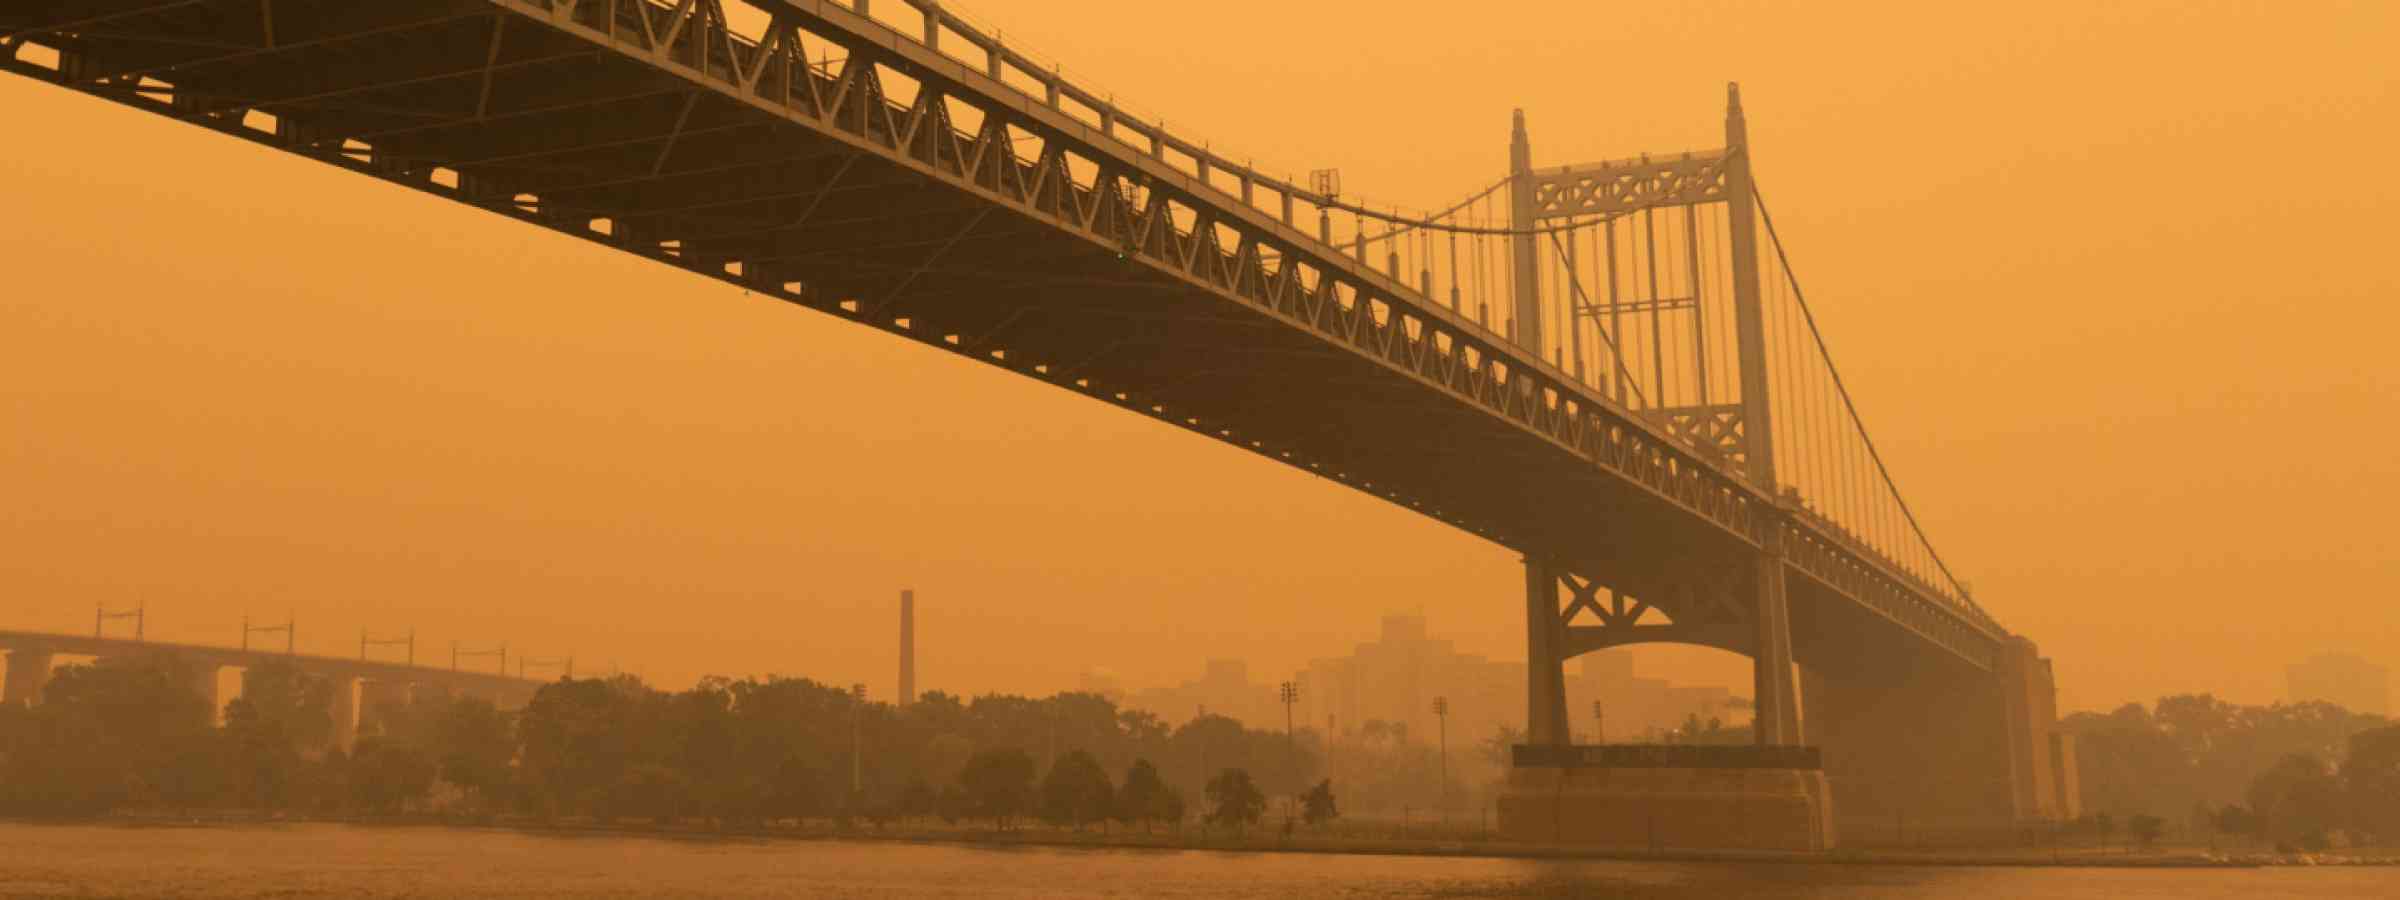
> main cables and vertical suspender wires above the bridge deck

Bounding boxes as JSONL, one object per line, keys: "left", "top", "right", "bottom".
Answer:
{"left": 628, "top": 0, "right": 1990, "bottom": 622}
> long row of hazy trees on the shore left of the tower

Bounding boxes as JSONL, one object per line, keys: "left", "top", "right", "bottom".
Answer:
{"left": 0, "top": 653, "right": 1337, "bottom": 828}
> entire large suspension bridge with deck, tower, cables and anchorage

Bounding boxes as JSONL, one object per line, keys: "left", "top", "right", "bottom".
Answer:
{"left": 0, "top": 0, "right": 2074, "bottom": 847}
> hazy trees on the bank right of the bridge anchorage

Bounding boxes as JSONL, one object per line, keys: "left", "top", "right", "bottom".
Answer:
{"left": 2059, "top": 694, "right": 2400, "bottom": 850}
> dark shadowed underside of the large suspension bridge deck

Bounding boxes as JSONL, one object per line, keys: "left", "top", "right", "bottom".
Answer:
{"left": 0, "top": 0, "right": 1740, "bottom": 578}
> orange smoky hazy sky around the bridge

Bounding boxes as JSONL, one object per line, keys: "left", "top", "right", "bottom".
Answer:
{"left": 0, "top": 0, "right": 2400, "bottom": 708}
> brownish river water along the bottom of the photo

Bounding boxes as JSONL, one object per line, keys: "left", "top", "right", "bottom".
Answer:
{"left": 0, "top": 823, "right": 2400, "bottom": 900}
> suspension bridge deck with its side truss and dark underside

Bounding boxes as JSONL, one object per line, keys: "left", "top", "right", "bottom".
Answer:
{"left": 0, "top": 0, "right": 2004, "bottom": 667}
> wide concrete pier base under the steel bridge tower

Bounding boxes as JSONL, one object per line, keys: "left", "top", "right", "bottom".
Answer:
{"left": 1500, "top": 746, "right": 1836, "bottom": 852}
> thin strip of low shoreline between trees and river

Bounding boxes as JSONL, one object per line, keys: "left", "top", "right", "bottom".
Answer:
{"left": 28, "top": 814, "right": 2400, "bottom": 869}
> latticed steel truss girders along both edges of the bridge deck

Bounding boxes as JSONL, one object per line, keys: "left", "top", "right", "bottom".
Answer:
{"left": 7, "top": 0, "right": 2002, "bottom": 672}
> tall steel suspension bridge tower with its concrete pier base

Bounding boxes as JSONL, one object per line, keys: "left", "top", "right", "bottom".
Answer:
{"left": 1500, "top": 86, "right": 1834, "bottom": 850}
